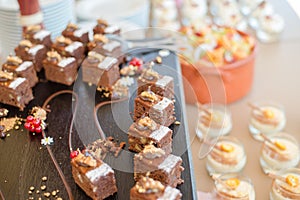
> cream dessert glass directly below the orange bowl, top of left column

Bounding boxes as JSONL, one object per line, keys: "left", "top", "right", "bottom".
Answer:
{"left": 196, "top": 104, "right": 232, "bottom": 140}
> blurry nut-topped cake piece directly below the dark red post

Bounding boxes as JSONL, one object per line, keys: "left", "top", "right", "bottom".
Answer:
{"left": 24, "top": 25, "right": 52, "bottom": 49}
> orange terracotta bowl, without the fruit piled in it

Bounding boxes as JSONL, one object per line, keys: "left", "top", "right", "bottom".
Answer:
{"left": 180, "top": 38, "right": 257, "bottom": 104}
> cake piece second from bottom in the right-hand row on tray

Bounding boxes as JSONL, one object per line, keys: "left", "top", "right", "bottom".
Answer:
{"left": 134, "top": 144, "right": 184, "bottom": 187}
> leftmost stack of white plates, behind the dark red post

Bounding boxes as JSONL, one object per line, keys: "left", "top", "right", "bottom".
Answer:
{"left": 0, "top": 0, "right": 76, "bottom": 58}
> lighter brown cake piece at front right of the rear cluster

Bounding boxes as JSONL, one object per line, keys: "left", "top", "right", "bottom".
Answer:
{"left": 82, "top": 51, "right": 120, "bottom": 88}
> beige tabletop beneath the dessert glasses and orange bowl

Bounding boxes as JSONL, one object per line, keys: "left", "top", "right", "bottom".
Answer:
{"left": 187, "top": 0, "right": 300, "bottom": 200}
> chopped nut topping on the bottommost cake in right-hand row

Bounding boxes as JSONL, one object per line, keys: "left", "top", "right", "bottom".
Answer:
{"left": 135, "top": 177, "right": 165, "bottom": 193}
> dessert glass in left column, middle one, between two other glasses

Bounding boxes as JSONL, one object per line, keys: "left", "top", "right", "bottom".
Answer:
{"left": 206, "top": 136, "right": 247, "bottom": 175}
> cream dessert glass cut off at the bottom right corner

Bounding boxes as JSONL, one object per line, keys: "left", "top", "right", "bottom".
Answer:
{"left": 270, "top": 168, "right": 300, "bottom": 200}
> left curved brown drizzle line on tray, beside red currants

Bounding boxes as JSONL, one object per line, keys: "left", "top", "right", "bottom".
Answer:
{"left": 42, "top": 90, "right": 78, "bottom": 200}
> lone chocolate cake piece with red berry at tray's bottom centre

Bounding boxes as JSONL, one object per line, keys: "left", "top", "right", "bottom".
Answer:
{"left": 71, "top": 150, "right": 117, "bottom": 200}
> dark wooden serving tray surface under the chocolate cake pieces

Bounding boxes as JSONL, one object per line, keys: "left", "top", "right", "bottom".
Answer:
{"left": 0, "top": 49, "right": 197, "bottom": 200}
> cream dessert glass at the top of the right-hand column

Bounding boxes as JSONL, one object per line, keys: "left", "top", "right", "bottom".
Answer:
{"left": 249, "top": 103, "right": 286, "bottom": 141}
